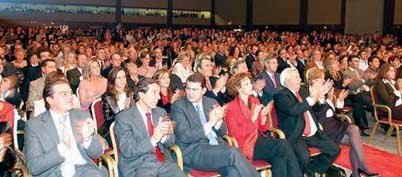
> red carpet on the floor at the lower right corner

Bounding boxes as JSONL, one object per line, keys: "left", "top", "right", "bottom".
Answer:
{"left": 335, "top": 144, "right": 402, "bottom": 177}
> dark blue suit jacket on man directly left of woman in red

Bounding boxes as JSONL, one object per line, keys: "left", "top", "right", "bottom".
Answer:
{"left": 170, "top": 96, "right": 227, "bottom": 158}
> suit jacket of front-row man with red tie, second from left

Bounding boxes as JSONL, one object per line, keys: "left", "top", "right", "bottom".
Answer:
{"left": 115, "top": 104, "right": 175, "bottom": 177}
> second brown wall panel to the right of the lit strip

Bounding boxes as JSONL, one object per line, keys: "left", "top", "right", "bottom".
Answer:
{"left": 253, "top": 0, "right": 300, "bottom": 25}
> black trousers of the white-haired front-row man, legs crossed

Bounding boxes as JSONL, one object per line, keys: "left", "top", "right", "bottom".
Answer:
{"left": 291, "top": 132, "right": 340, "bottom": 173}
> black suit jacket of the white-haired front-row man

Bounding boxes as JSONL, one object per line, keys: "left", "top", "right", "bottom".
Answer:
{"left": 274, "top": 87, "right": 321, "bottom": 144}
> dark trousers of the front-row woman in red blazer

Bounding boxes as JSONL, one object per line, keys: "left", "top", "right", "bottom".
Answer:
{"left": 253, "top": 135, "right": 303, "bottom": 177}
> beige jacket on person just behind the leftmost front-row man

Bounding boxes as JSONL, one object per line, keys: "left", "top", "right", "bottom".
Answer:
{"left": 26, "top": 77, "right": 45, "bottom": 110}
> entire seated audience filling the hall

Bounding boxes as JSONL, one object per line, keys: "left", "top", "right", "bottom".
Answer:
{"left": 0, "top": 26, "right": 402, "bottom": 177}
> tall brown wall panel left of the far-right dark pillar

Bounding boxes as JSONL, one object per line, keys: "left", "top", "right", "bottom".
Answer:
{"left": 345, "top": 0, "right": 384, "bottom": 34}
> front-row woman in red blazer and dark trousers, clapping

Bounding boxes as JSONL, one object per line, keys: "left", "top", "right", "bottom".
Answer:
{"left": 225, "top": 73, "right": 303, "bottom": 177}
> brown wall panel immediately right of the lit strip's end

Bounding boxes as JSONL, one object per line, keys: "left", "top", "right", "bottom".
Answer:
{"left": 215, "top": 0, "right": 246, "bottom": 25}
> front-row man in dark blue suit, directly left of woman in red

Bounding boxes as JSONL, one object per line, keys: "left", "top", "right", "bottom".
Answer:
{"left": 170, "top": 73, "right": 259, "bottom": 177}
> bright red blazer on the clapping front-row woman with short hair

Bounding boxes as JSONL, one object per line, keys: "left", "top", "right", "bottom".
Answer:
{"left": 225, "top": 96, "right": 269, "bottom": 160}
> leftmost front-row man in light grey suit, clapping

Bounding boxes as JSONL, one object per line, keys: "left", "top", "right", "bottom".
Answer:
{"left": 24, "top": 79, "right": 107, "bottom": 177}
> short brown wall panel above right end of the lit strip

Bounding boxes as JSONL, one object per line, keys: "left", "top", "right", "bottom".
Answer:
{"left": 172, "top": 0, "right": 211, "bottom": 11}
